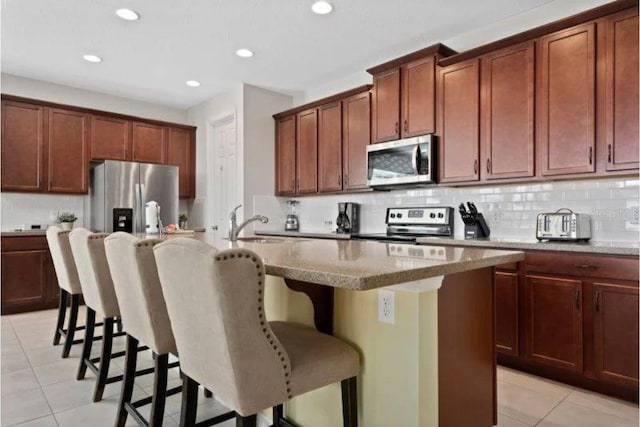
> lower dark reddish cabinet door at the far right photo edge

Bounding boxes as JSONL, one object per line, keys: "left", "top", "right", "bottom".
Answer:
{"left": 593, "top": 283, "right": 640, "bottom": 389}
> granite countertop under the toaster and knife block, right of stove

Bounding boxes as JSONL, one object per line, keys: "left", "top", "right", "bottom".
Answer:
{"left": 417, "top": 237, "right": 640, "bottom": 256}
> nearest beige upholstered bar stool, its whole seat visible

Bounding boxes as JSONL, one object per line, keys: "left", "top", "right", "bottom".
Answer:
{"left": 153, "top": 238, "right": 360, "bottom": 427}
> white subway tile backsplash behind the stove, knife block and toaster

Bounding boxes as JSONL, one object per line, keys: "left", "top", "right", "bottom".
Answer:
{"left": 254, "top": 177, "right": 640, "bottom": 242}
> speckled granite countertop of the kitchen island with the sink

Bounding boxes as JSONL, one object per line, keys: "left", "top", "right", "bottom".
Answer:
{"left": 161, "top": 234, "right": 524, "bottom": 290}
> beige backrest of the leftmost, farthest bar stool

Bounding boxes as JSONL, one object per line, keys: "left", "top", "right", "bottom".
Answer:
{"left": 47, "top": 225, "right": 82, "bottom": 295}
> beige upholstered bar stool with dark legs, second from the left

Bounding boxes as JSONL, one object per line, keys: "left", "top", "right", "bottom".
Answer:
{"left": 69, "top": 228, "right": 129, "bottom": 402}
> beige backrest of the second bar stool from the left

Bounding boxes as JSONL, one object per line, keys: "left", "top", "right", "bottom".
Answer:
{"left": 69, "top": 228, "right": 120, "bottom": 317}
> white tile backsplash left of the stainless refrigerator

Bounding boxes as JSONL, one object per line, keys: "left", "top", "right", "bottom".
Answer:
{"left": 0, "top": 193, "right": 88, "bottom": 231}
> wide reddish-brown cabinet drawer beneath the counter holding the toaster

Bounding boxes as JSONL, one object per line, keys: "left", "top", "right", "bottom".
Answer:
{"left": 525, "top": 252, "right": 638, "bottom": 282}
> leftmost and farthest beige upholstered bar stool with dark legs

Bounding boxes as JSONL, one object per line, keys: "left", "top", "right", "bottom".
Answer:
{"left": 47, "top": 226, "right": 85, "bottom": 359}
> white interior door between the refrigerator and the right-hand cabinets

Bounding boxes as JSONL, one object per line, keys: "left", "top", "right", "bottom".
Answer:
{"left": 207, "top": 114, "right": 239, "bottom": 238}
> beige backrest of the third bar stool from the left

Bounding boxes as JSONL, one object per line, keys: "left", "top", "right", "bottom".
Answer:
{"left": 104, "top": 232, "right": 176, "bottom": 354}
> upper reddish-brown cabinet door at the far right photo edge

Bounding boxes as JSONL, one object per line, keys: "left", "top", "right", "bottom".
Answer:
{"left": 605, "top": 9, "right": 640, "bottom": 170}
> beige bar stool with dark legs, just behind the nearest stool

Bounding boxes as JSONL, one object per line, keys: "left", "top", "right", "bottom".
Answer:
{"left": 104, "top": 232, "right": 222, "bottom": 427}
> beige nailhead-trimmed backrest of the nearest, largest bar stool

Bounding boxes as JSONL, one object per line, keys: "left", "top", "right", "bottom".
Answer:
{"left": 153, "top": 238, "right": 291, "bottom": 414}
